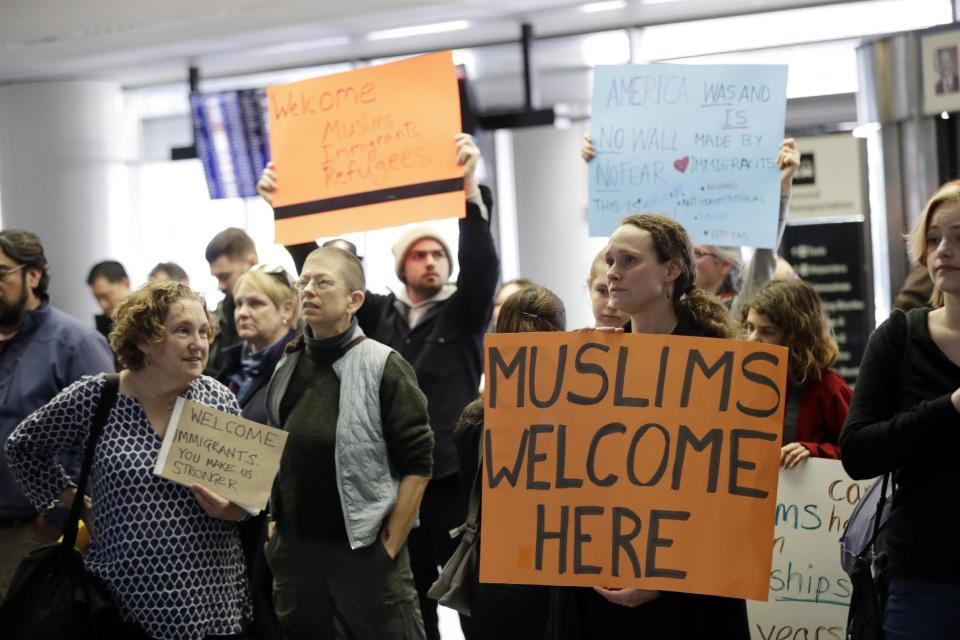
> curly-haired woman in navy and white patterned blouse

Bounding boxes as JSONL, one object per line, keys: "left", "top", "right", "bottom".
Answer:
{"left": 6, "top": 282, "right": 250, "bottom": 640}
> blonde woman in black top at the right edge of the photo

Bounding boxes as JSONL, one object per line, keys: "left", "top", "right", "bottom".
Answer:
{"left": 840, "top": 180, "right": 960, "bottom": 640}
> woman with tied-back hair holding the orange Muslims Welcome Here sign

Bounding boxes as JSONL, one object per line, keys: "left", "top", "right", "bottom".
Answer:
{"left": 547, "top": 213, "right": 750, "bottom": 640}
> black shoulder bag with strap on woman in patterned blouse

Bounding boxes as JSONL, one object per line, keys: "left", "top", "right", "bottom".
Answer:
{"left": 0, "top": 374, "right": 125, "bottom": 640}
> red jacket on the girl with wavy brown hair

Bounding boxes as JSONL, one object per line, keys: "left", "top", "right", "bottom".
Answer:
{"left": 797, "top": 369, "right": 853, "bottom": 460}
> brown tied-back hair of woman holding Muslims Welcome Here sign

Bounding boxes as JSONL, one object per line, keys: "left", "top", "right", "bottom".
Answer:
{"left": 620, "top": 213, "right": 735, "bottom": 338}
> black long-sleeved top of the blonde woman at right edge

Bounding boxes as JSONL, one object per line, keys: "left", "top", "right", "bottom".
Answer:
{"left": 840, "top": 308, "right": 960, "bottom": 584}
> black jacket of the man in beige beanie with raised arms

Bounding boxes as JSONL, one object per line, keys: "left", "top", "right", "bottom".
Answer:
{"left": 357, "top": 182, "right": 500, "bottom": 478}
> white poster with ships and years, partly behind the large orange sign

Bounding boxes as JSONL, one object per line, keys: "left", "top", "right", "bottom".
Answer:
{"left": 747, "top": 458, "right": 873, "bottom": 640}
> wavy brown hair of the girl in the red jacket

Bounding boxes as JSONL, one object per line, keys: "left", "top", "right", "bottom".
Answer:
{"left": 740, "top": 280, "right": 838, "bottom": 385}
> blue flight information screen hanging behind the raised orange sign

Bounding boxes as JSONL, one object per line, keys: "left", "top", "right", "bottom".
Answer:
{"left": 190, "top": 89, "right": 270, "bottom": 199}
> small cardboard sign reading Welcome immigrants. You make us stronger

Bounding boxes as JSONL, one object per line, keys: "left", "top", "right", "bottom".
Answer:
{"left": 153, "top": 397, "right": 287, "bottom": 510}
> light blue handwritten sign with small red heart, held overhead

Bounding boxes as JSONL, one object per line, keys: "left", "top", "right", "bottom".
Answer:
{"left": 589, "top": 64, "right": 787, "bottom": 249}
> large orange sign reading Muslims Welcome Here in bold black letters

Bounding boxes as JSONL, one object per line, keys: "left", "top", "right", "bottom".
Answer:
{"left": 480, "top": 333, "right": 787, "bottom": 600}
